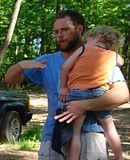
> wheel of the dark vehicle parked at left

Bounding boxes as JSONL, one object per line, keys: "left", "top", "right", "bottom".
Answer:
{"left": 3, "top": 111, "right": 21, "bottom": 142}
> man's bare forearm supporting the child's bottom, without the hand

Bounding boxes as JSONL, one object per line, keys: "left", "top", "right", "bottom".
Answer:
{"left": 83, "top": 82, "right": 129, "bottom": 111}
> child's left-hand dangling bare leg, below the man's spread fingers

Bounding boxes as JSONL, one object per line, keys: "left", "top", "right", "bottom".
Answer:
{"left": 67, "top": 116, "right": 85, "bottom": 160}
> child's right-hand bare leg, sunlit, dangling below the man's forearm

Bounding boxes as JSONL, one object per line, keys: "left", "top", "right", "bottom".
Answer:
{"left": 98, "top": 117, "right": 123, "bottom": 160}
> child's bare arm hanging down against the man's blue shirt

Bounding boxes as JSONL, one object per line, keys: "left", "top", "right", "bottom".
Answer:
{"left": 59, "top": 47, "right": 83, "bottom": 101}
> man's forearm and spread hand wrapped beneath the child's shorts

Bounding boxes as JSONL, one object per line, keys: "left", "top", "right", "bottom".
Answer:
{"left": 55, "top": 82, "right": 129, "bottom": 123}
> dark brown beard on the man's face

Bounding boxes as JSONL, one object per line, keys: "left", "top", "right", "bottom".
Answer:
{"left": 58, "top": 37, "right": 79, "bottom": 52}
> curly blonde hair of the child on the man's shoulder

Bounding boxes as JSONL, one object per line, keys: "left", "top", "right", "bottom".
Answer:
{"left": 87, "top": 26, "right": 120, "bottom": 51}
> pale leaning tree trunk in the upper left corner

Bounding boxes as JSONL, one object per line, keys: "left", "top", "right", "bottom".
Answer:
{"left": 0, "top": 0, "right": 22, "bottom": 64}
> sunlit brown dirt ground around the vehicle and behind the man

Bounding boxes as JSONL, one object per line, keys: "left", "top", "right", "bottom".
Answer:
{"left": 0, "top": 94, "right": 130, "bottom": 160}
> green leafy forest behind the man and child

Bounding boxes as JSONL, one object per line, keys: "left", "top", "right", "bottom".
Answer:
{"left": 0, "top": 0, "right": 130, "bottom": 86}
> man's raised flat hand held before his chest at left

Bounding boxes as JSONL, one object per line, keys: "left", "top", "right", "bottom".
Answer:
{"left": 18, "top": 60, "right": 47, "bottom": 70}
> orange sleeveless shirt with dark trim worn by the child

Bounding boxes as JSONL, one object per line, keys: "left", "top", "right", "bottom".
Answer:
{"left": 68, "top": 45, "right": 116, "bottom": 90}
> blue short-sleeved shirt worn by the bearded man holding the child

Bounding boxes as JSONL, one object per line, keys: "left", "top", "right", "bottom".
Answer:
{"left": 24, "top": 51, "right": 123, "bottom": 141}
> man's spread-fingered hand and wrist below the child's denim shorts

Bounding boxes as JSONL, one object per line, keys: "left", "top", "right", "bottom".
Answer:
{"left": 55, "top": 100, "right": 86, "bottom": 123}
